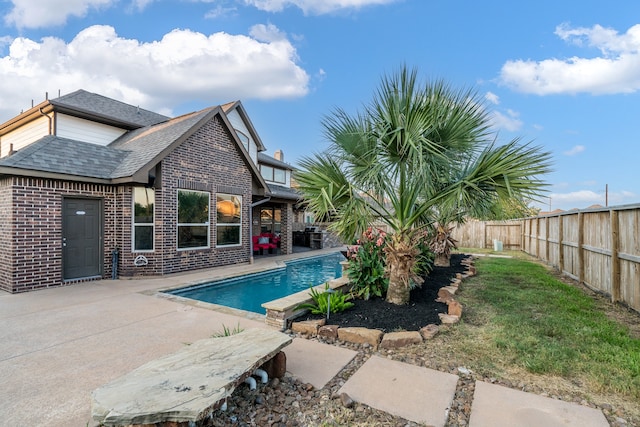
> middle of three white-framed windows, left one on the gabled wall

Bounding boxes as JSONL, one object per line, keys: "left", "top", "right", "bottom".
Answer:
{"left": 178, "top": 190, "right": 209, "bottom": 249}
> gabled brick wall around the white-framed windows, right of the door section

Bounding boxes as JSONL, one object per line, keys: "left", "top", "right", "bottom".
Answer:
{"left": 119, "top": 116, "right": 252, "bottom": 276}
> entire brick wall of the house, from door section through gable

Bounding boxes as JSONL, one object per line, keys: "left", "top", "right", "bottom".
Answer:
{"left": 0, "top": 117, "right": 260, "bottom": 292}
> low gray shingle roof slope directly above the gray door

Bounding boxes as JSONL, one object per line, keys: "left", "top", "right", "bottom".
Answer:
{"left": 0, "top": 135, "right": 127, "bottom": 179}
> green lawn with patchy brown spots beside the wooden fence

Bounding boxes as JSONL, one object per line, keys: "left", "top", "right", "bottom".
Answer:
{"left": 452, "top": 257, "right": 640, "bottom": 412}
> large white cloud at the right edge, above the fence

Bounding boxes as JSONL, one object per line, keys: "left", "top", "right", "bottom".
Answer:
{"left": 500, "top": 24, "right": 640, "bottom": 95}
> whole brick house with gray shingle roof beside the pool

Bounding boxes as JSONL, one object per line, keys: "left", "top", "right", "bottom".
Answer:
{"left": 0, "top": 90, "right": 298, "bottom": 292}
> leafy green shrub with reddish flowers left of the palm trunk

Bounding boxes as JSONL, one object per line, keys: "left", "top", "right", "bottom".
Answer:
{"left": 347, "top": 227, "right": 389, "bottom": 300}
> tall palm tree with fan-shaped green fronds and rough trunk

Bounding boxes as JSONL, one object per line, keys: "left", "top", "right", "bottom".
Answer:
{"left": 296, "top": 66, "right": 550, "bottom": 304}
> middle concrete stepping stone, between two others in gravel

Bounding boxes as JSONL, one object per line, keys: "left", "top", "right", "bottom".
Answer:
{"left": 339, "top": 356, "right": 458, "bottom": 427}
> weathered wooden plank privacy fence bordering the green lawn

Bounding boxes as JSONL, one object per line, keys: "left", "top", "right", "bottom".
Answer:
{"left": 453, "top": 204, "right": 640, "bottom": 311}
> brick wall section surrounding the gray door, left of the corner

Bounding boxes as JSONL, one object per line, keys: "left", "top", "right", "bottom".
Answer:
{"left": 0, "top": 177, "right": 116, "bottom": 293}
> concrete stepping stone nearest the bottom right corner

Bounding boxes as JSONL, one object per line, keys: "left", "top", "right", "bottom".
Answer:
{"left": 469, "top": 381, "right": 609, "bottom": 427}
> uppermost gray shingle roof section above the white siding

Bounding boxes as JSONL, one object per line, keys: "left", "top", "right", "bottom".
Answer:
{"left": 49, "top": 89, "right": 169, "bottom": 127}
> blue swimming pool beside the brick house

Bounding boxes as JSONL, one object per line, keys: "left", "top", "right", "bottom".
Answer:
{"left": 170, "top": 252, "right": 345, "bottom": 314}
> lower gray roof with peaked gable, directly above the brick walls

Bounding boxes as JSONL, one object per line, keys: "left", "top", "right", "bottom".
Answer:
{"left": 0, "top": 103, "right": 269, "bottom": 193}
